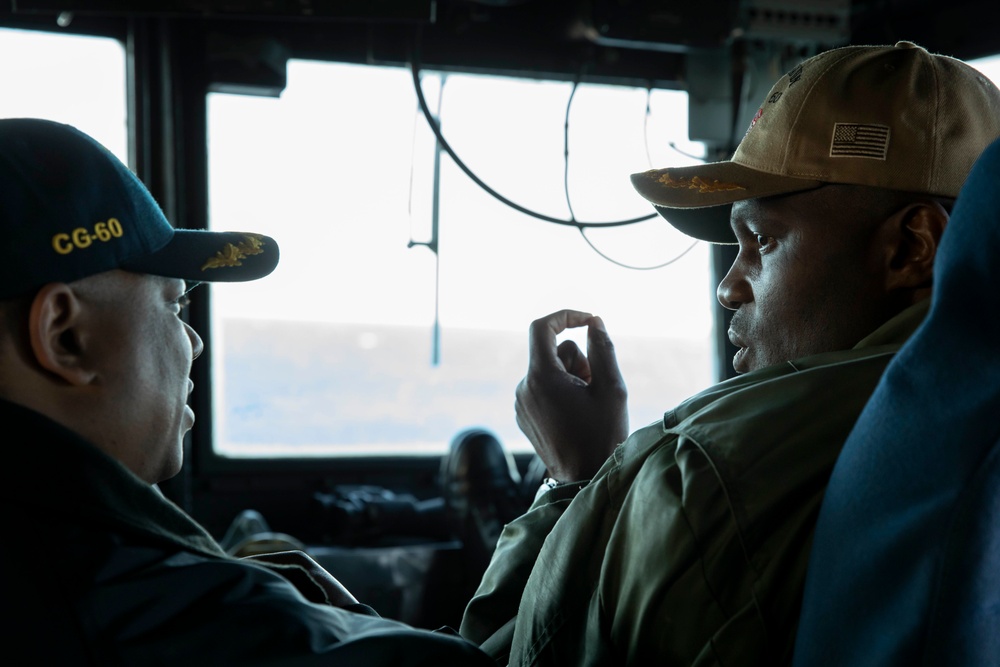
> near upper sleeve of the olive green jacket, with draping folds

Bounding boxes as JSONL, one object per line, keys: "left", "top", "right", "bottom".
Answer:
{"left": 496, "top": 427, "right": 780, "bottom": 666}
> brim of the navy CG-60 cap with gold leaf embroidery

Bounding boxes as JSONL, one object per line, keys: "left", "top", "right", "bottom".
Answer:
{"left": 121, "top": 229, "right": 279, "bottom": 282}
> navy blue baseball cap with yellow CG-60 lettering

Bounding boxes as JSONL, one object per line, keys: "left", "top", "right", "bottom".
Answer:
{"left": 0, "top": 118, "right": 278, "bottom": 299}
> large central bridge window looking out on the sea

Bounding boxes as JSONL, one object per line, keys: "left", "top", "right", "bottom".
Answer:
{"left": 202, "top": 60, "right": 715, "bottom": 457}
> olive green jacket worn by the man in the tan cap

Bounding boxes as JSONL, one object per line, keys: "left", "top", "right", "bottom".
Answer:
{"left": 461, "top": 302, "right": 928, "bottom": 667}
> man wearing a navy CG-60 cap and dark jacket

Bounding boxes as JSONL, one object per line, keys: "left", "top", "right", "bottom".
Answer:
{"left": 0, "top": 119, "right": 493, "bottom": 665}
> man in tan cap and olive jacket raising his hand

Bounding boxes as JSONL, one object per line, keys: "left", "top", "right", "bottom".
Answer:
{"left": 461, "top": 42, "right": 1000, "bottom": 666}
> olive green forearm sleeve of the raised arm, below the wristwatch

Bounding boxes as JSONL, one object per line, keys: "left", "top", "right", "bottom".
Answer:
{"left": 460, "top": 483, "right": 584, "bottom": 662}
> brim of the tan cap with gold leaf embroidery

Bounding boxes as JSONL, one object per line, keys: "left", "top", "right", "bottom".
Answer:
{"left": 632, "top": 162, "right": 823, "bottom": 243}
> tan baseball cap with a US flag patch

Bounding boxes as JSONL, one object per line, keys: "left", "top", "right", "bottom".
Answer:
{"left": 632, "top": 42, "right": 1000, "bottom": 243}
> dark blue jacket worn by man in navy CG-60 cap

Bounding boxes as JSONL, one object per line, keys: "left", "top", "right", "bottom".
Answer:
{"left": 0, "top": 401, "right": 494, "bottom": 667}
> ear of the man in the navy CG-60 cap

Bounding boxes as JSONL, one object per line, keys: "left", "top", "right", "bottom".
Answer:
{"left": 28, "top": 283, "right": 96, "bottom": 386}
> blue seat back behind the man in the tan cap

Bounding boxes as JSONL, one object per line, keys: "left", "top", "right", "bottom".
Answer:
{"left": 794, "top": 138, "right": 1000, "bottom": 667}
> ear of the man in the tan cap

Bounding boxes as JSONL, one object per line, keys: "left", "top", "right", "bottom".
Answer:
{"left": 886, "top": 200, "right": 949, "bottom": 291}
